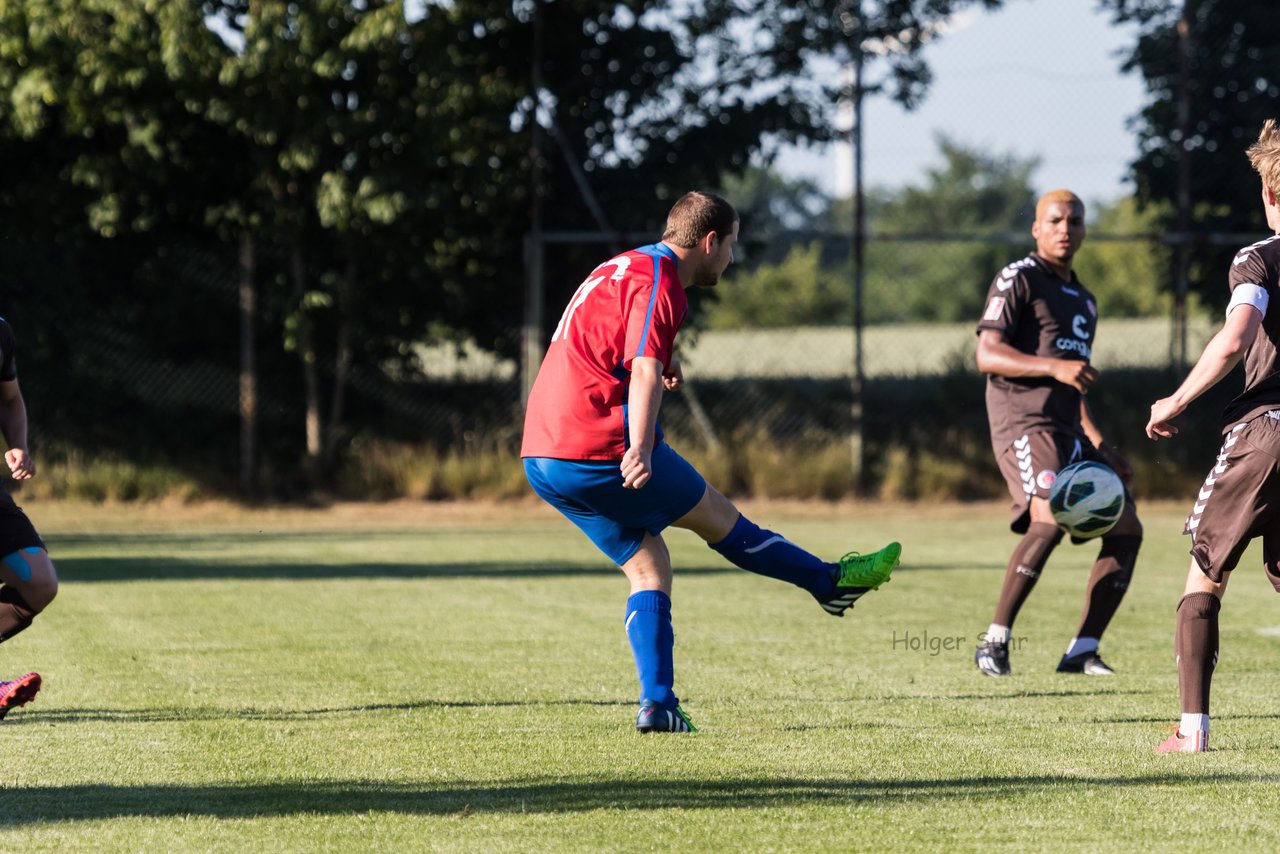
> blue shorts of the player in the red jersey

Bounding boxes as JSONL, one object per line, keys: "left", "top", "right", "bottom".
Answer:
{"left": 525, "top": 442, "right": 707, "bottom": 566}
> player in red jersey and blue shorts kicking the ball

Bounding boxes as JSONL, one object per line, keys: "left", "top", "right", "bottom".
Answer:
{"left": 521, "top": 192, "right": 901, "bottom": 732}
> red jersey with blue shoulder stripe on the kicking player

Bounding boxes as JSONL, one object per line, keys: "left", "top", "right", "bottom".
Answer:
{"left": 520, "top": 243, "right": 689, "bottom": 460}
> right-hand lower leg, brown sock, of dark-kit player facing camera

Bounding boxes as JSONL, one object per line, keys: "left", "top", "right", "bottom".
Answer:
{"left": 1057, "top": 504, "right": 1142, "bottom": 676}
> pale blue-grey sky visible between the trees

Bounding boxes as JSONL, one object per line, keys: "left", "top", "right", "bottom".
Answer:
{"left": 777, "top": 0, "right": 1143, "bottom": 202}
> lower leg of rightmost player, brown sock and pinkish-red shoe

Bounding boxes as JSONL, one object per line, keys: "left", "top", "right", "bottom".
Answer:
{"left": 1156, "top": 560, "right": 1230, "bottom": 753}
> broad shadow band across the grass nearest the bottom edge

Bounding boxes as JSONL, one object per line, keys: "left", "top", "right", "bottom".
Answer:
{"left": 0, "top": 769, "right": 1280, "bottom": 827}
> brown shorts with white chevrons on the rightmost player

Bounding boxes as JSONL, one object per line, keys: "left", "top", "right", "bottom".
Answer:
{"left": 1183, "top": 410, "right": 1280, "bottom": 590}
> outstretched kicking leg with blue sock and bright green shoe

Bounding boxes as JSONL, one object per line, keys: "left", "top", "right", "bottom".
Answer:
{"left": 673, "top": 484, "right": 902, "bottom": 617}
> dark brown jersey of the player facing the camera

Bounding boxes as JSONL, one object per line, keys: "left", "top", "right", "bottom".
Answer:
{"left": 978, "top": 254, "right": 1098, "bottom": 456}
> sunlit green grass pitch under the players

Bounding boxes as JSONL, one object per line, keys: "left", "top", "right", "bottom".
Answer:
{"left": 0, "top": 503, "right": 1280, "bottom": 851}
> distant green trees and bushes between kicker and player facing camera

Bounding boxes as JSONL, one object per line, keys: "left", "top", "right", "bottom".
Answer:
{"left": 709, "top": 136, "right": 1037, "bottom": 329}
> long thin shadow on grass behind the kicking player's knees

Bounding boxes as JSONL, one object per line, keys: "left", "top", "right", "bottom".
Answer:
{"left": 54, "top": 554, "right": 742, "bottom": 583}
